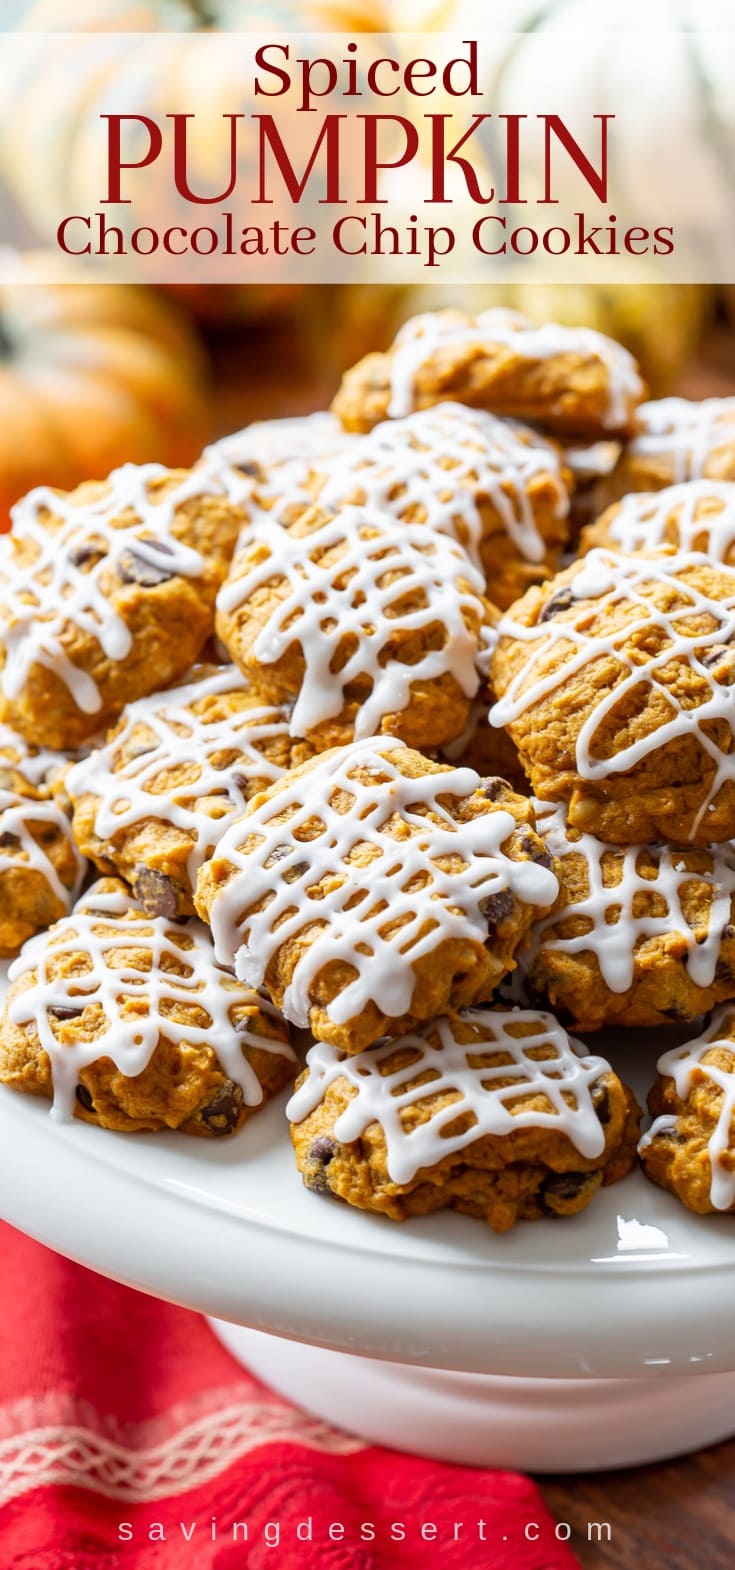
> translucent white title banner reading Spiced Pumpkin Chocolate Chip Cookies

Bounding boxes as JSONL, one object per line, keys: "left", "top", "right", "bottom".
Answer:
{"left": 0, "top": 27, "right": 735, "bottom": 286}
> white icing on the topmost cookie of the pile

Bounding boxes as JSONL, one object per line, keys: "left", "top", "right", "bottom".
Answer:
{"left": 388, "top": 308, "right": 642, "bottom": 430}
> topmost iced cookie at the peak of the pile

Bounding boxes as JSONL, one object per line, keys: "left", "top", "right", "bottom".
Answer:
{"left": 331, "top": 309, "right": 645, "bottom": 440}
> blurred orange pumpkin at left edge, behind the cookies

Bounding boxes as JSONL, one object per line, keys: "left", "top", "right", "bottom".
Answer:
{"left": 0, "top": 261, "right": 209, "bottom": 529}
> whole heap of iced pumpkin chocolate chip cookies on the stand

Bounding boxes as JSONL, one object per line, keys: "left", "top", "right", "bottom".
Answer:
{"left": 0, "top": 311, "right": 735, "bottom": 1231}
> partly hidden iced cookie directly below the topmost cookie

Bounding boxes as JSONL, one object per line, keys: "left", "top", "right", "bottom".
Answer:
{"left": 301, "top": 403, "right": 569, "bottom": 608}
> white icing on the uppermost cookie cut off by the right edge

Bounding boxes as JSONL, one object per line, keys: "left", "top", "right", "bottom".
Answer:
{"left": 627, "top": 397, "right": 735, "bottom": 482}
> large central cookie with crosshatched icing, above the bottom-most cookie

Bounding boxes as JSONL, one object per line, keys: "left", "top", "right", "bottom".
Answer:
{"left": 196, "top": 736, "right": 559, "bottom": 1052}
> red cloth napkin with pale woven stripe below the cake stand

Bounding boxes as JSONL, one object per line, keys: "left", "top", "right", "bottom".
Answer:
{"left": 0, "top": 1223, "right": 580, "bottom": 1570}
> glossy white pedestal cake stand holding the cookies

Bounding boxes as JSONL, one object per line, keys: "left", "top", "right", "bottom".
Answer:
{"left": 0, "top": 1004, "right": 735, "bottom": 1471}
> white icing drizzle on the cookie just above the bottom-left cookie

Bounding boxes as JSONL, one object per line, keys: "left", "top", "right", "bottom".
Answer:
{"left": 64, "top": 666, "right": 295, "bottom": 884}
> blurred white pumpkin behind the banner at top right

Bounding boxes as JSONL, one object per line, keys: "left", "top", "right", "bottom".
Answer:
{"left": 430, "top": 0, "right": 735, "bottom": 260}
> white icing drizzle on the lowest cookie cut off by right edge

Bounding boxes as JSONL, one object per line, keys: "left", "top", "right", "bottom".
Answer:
{"left": 638, "top": 1003, "right": 735, "bottom": 1210}
